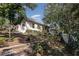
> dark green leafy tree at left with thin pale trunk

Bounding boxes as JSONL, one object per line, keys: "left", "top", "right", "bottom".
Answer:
{"left": 0, "top": 3, "right": 36, "bottom": 39}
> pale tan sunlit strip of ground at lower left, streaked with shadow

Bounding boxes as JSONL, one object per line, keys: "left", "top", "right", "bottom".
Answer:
{"left": 0, "top": 44, "right": 29, "bottom": 56}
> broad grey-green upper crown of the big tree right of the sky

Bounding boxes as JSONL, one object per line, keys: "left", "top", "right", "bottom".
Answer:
{"left": 43, "top": 3, "right": 79, "bottom": 33}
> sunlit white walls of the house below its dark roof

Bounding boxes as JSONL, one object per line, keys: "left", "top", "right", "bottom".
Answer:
{"left": 18, "top": 21, "right": 43, "bottom": 33}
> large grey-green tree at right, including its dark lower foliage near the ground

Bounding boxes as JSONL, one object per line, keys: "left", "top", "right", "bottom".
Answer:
{"left": 43, "top": 3, "right": 79, "bottom": 52}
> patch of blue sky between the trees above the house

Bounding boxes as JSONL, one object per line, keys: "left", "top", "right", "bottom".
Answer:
{"left": 26, "top": 3, "right": 46, "bottom": 23}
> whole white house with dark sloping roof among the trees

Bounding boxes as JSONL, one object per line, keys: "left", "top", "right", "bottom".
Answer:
{"left": 17, "top": 18, "right": 46, "bottom": 33}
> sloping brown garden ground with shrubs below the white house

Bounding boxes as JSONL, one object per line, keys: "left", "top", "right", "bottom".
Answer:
{"left": 0, "top": 28, "right": 77, "bottom": 56}
